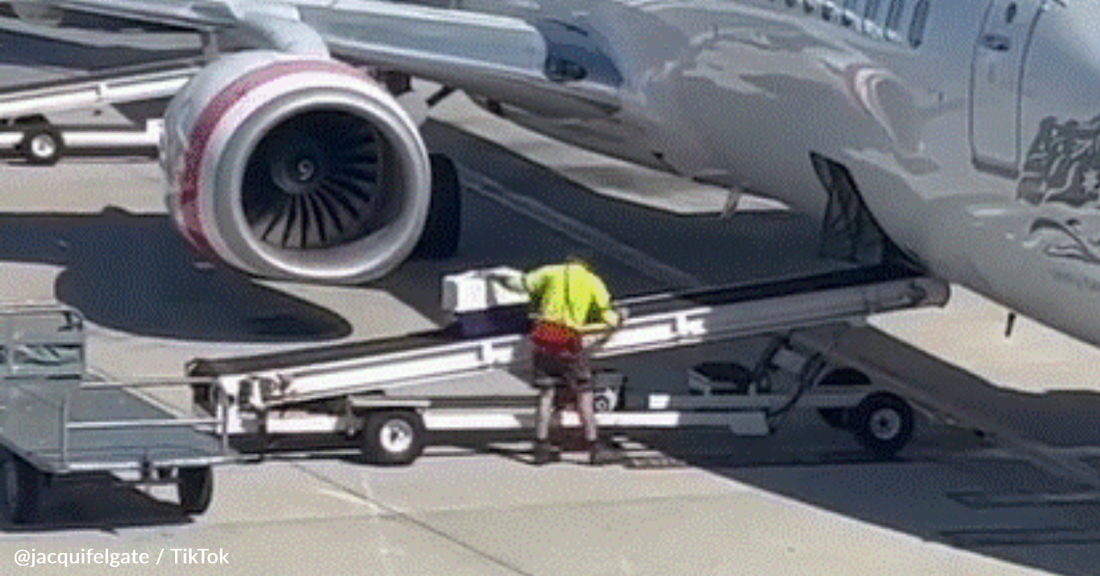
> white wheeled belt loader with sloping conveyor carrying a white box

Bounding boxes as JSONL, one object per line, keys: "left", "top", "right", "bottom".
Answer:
{"left": 188, "top": 265, "right": 948, "bottom": 465}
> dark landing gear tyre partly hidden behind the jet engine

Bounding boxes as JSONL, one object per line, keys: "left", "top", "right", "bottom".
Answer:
{"left": 414, "top": 154, "right": 462, "bottom": 259}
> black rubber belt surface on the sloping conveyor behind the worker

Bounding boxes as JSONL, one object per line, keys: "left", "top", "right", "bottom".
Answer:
{"left": 188, "top": 265, "right": 921, "bottom": 377}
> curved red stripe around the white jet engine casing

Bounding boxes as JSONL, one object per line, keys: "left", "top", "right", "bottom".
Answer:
{"left": 179, "top": 60, "right": 356, "bottom": 253}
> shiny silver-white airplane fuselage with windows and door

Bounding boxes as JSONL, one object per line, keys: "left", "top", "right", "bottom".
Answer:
{"left": 477, "top": 0, "right": 1100, "bottom": 343}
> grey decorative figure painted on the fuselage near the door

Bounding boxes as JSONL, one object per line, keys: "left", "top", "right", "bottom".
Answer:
{"left": 1016, "top": 117, "right": 1100, "bottom": 265}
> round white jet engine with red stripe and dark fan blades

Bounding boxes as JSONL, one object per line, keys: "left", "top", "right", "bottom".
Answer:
{"left": 163, "top": 52, "right": 431, "bottom": 284}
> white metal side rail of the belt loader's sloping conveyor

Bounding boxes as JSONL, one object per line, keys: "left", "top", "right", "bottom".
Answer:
{"left": 255, "top": 277, "right": 946, "bottom": 405}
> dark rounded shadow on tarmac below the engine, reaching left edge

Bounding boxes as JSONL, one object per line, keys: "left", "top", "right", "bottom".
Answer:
{"left": 0, "top": 208, "right": 351, "bottom": 343}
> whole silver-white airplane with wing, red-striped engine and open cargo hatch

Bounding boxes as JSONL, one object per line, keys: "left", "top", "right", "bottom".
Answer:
{"left": 6, "top": 0, "right": 1100, "bottom": 351}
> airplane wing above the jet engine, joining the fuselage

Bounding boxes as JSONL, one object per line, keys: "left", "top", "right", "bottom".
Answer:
{"left": 24, "top": 0, "right": 623, "bottom": 117}
